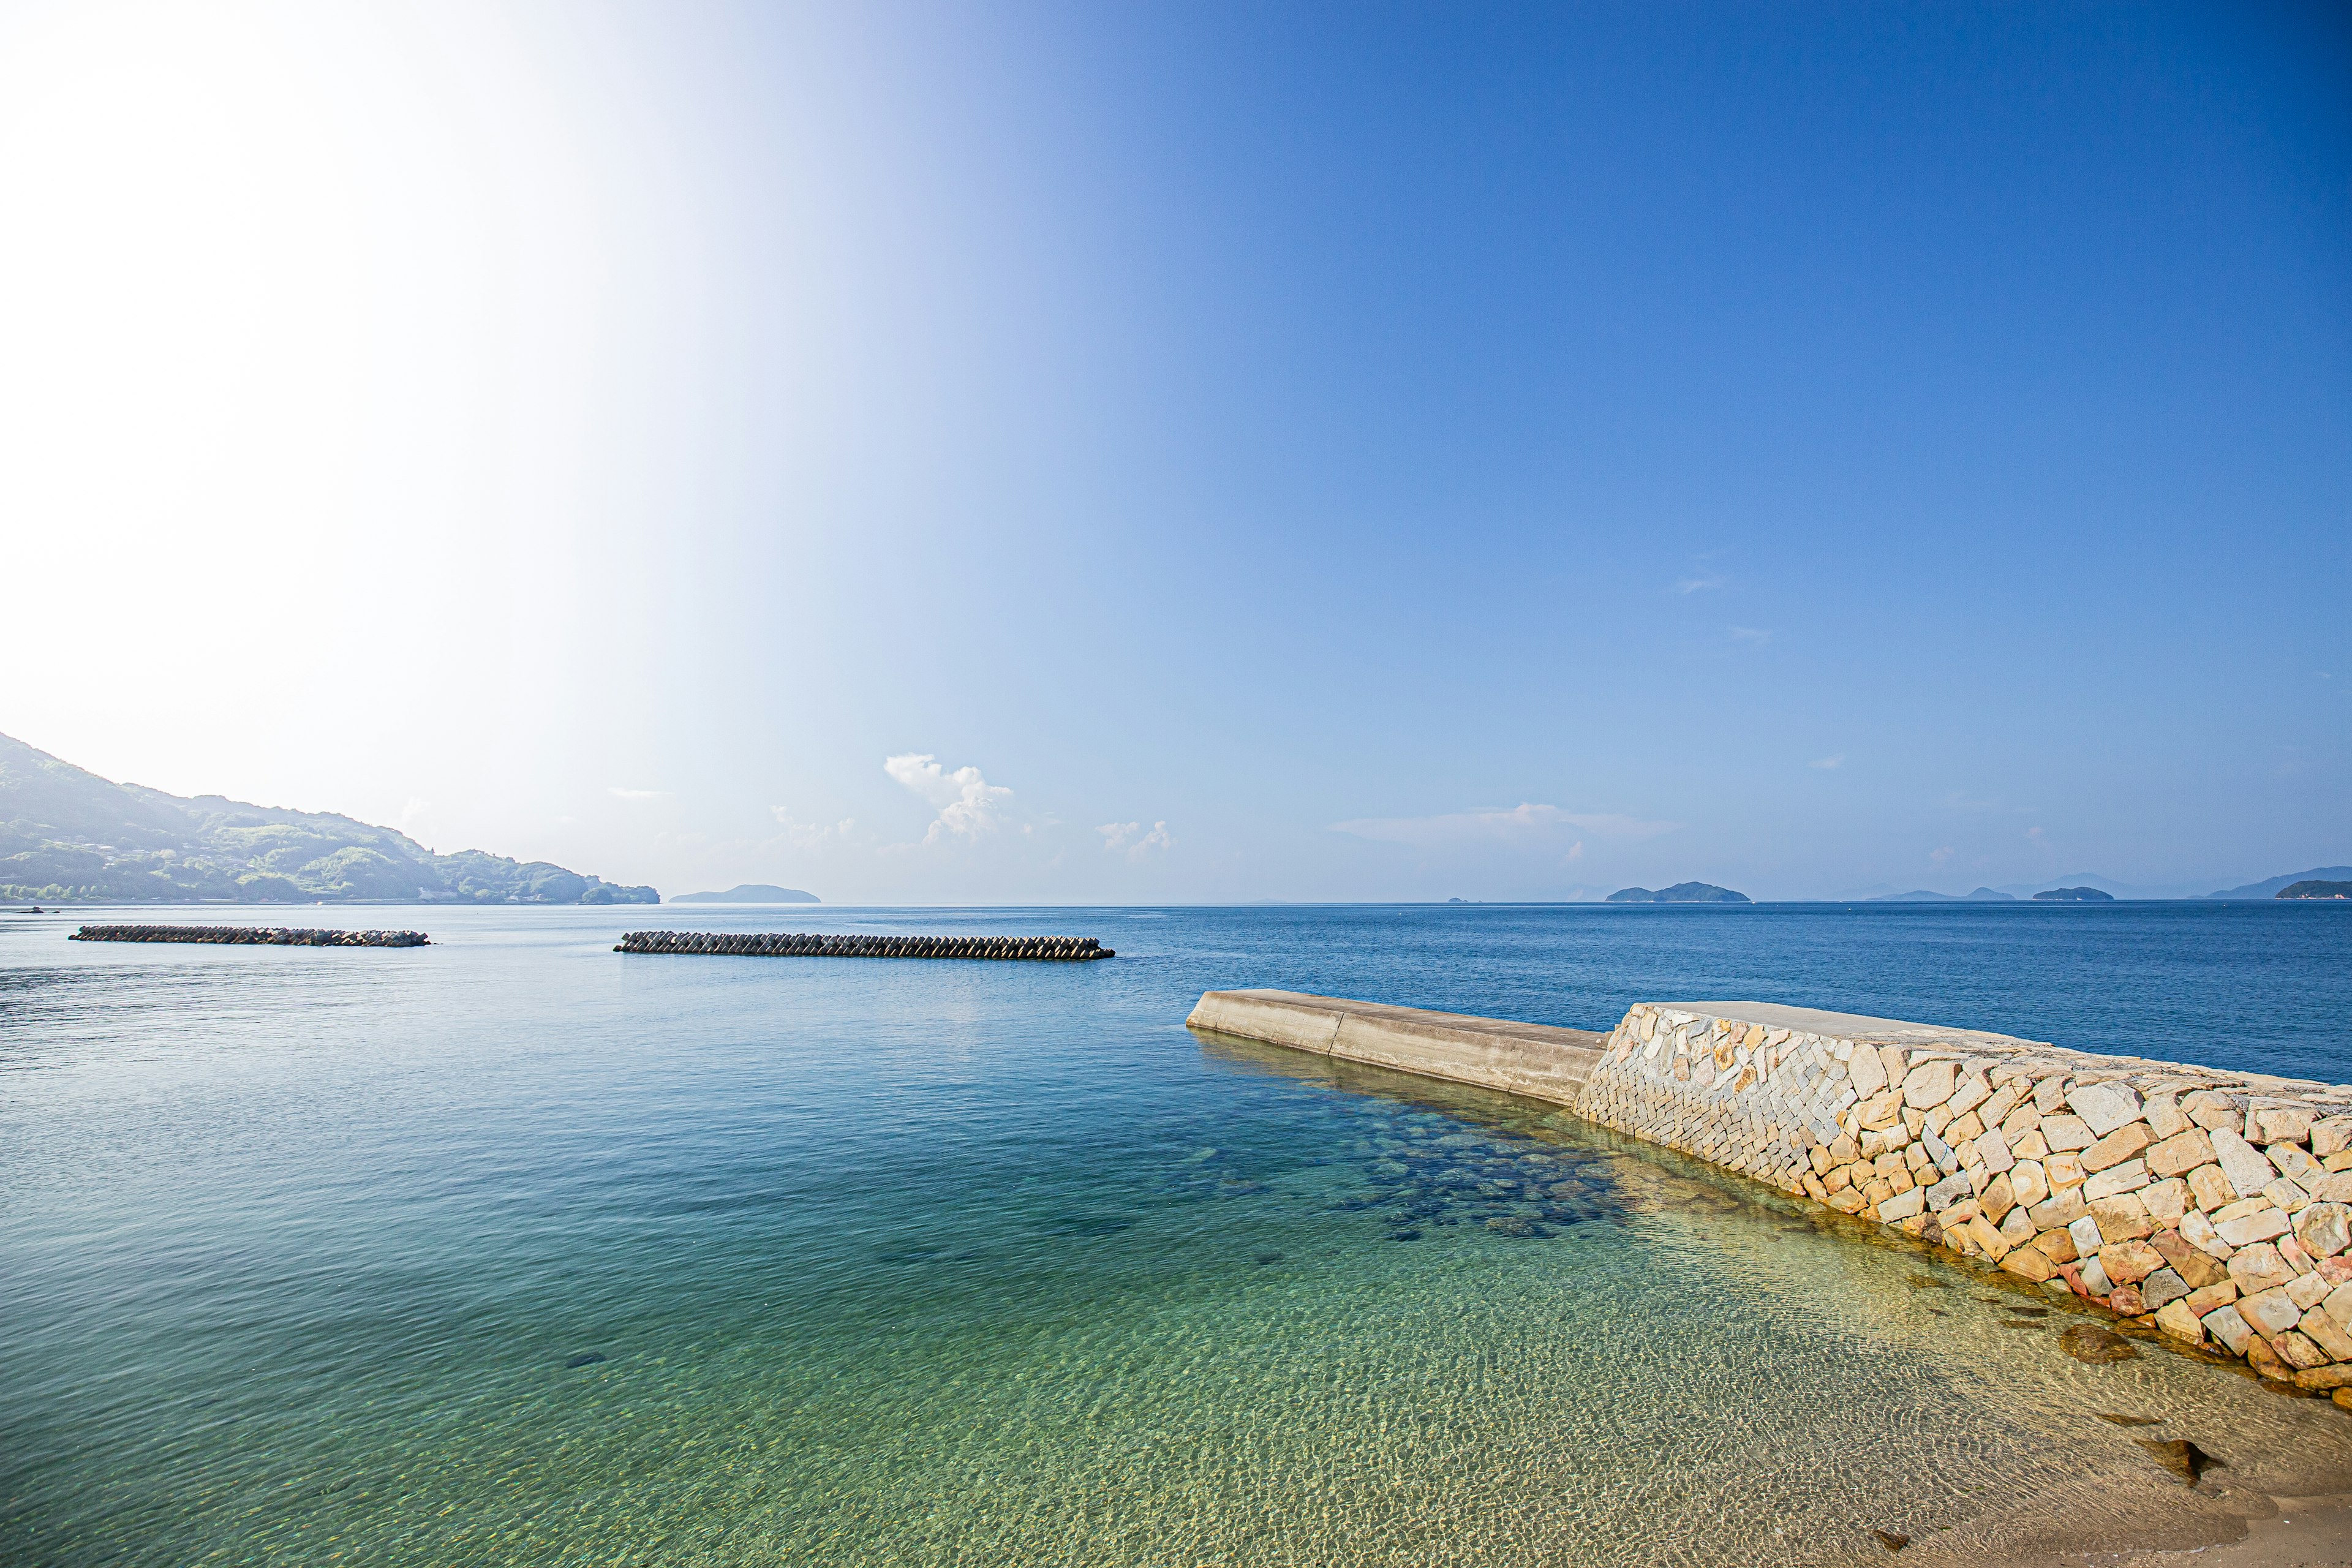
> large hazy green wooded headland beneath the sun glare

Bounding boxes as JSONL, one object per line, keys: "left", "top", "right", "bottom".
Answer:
{"left": 0, "top": 736, "right": 661, "bottom": 903}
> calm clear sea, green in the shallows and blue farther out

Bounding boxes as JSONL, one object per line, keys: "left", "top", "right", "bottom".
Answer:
{"left": 0, "top": 905, "right": 2352, "bottom": 1563}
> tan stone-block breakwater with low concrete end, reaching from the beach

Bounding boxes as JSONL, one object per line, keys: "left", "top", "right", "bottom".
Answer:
{"left": 1188, "top": 992, "right": 2352, "bottom": 1408}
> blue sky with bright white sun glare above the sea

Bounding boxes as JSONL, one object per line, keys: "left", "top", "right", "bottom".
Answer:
{"left": 0, "top": 5, "right": 2352, "bottom": 903}
